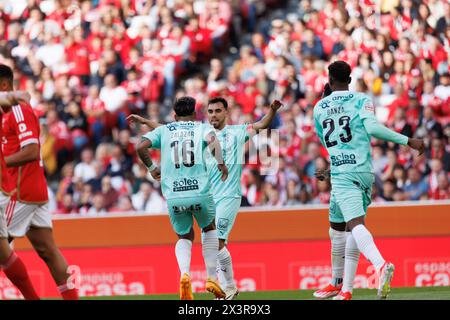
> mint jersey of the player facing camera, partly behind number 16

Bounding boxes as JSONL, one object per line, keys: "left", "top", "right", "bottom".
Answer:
{"left": 208, "top": 125, "right": 249, "bottom": 201}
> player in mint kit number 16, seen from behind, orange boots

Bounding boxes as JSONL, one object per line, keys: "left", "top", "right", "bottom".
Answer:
{"left": 137, "top": 97, "right": 228, "bottom": 300}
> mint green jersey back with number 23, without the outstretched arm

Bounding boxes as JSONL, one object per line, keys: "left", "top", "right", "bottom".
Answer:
{"left": 314, "top": 91, "right": 375, "bottom": 174}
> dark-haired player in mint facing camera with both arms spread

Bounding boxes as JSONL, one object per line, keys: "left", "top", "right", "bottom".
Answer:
{"left": 128, "top": 97, "right": 281, "bottom": 300}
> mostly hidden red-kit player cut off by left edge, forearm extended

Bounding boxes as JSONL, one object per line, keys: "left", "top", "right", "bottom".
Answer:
{"left": 0, "top": 86, "right": 39, "bottom": 300}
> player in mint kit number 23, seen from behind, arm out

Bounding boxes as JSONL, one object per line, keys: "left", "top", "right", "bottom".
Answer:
{"left": 314, "top": 61, "right": 425, "bottom": 300}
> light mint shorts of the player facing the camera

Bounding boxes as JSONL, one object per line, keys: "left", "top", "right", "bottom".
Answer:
{"left": 215, "top": 197, "right": 241, "bottom": 241}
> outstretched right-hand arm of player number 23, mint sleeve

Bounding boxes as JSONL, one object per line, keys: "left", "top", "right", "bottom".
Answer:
{"left": 360, "top": 100, "right": 425, "bottom": 155}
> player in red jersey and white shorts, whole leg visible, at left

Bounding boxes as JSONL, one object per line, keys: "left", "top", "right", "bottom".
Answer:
{"left": 0, "top": 65, "right": 78, "bottom": 300}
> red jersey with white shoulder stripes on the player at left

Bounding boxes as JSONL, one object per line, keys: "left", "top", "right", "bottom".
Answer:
{"left": 2, "top": 104, "right": 48, "bottom": 204}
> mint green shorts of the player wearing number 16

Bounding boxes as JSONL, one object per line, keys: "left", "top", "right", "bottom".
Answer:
{"left": 167, "top": 195, "right": 216, "bottom": 235}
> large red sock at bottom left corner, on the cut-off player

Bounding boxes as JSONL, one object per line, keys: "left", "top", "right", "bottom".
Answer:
{"left": 2, "top": 251, "right": 39, "bottom": 300}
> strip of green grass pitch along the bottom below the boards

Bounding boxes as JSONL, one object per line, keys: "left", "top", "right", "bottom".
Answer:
{"left": 83, "top": 287, "right": 450, "bottom": 300}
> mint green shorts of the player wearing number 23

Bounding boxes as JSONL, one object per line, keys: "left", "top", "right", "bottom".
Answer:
{"left": 329, "top": 172, "right": 375, "bottom": 223}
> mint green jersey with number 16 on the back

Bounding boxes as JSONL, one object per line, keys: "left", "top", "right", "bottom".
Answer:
{"left": 142, "top": 121, "right": 217, "bottom": 199}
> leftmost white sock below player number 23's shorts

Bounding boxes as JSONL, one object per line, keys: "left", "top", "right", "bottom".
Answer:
{"left": 329, "top": 228, "right": 345, "bottom": 287}
